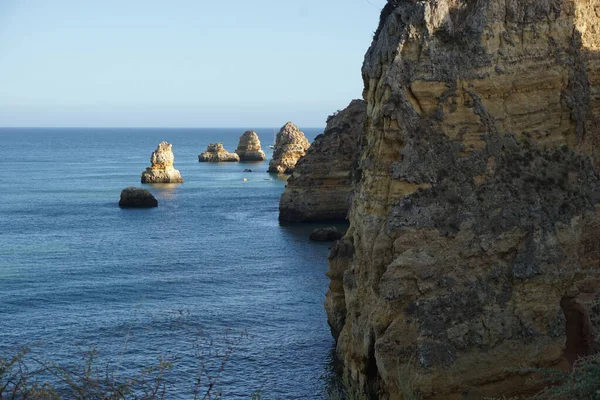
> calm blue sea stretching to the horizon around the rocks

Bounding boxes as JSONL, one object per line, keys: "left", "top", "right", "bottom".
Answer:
{"left": 0, "top": 128, "right": 334, "bottom": 399}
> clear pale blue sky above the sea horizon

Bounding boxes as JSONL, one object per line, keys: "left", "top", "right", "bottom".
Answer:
{"left": 0, "top": 0, "right": 385, "bottom": 127}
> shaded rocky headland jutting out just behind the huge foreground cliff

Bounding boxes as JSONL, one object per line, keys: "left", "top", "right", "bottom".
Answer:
{"left": 279, "top": 100, "right": 367, "bottom": 222}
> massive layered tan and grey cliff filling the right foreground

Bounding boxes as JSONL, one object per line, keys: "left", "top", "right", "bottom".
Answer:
{"left": 326, "top": 0, "right": 600, "bottom": 399}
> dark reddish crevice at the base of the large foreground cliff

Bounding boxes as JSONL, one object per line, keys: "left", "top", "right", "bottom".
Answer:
{"left": 560, "top": 296, "right": 600, "bottom": 367}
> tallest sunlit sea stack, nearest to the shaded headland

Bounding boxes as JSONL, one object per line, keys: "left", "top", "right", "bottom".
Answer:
{"left": 267, "top": 122, "right": 310, "bottom": 174}
